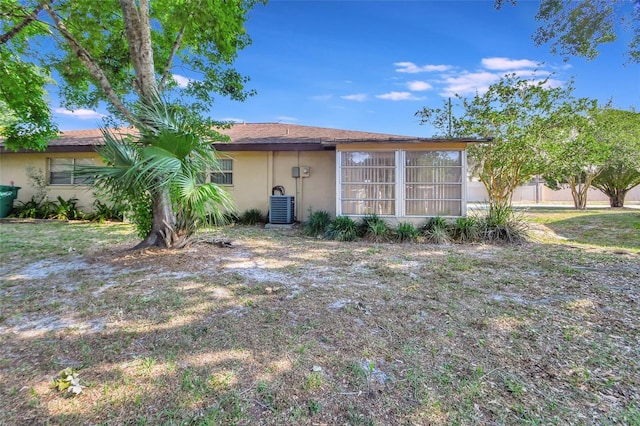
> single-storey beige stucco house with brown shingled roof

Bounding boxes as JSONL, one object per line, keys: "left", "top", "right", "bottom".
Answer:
{"left": 0, "top": 123, "right": 479, "bottom": 221}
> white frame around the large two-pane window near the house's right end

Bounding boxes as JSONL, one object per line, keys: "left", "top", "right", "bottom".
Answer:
{"left": 336, "top": 148, "right": 467, "bottom": 219}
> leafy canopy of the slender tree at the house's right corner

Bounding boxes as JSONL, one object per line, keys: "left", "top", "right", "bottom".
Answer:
{"left": 416, "top": 74, "right": 588, "bottom": 210}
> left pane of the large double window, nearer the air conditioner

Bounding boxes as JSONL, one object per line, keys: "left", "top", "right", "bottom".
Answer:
{"left": 340, "top": 152, "right": 396, "bottom": 215}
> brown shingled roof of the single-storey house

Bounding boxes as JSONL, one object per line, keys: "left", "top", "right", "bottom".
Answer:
{"left": 0, "top": 123, "right": 478, "bottom": 153}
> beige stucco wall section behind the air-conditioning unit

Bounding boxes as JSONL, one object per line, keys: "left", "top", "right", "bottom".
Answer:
{"left": 225, "top": 151, "right": 336, "bottom": 221}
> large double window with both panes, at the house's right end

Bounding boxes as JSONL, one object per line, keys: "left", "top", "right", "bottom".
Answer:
{"left": 337, "top": 150, "right": 465, "bottom": 217}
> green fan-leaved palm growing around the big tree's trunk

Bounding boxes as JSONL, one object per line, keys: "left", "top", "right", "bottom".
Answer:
{"left": 75, "top": 99, "right": 235, "bottom": 249}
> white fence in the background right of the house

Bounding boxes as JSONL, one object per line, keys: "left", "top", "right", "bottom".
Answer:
{"left": 467, "top": 182, "right": 640, "bottom": 205}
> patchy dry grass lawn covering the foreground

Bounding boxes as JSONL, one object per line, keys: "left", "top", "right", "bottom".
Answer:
{"left": 0, "top": 209, "right": 640, "bottom": 425}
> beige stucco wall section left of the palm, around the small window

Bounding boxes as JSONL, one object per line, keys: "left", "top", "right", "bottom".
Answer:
{"left": 0, "top": 152, "right": 100, "bottom": 211}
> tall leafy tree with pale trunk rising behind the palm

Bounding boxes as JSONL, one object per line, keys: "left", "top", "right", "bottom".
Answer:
{"left": 3, "top": 0, "right": 258, "bottom": 247}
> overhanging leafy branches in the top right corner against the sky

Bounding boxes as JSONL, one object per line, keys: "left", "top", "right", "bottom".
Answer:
{"left": 495, "top": 0, "right": 640, "bottom": 63}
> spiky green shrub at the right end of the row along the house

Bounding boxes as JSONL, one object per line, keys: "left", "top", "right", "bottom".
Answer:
{"left": 479, "top": 205, "right": 527, "bottom": 243}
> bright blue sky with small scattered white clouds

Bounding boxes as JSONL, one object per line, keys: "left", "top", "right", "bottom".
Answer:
{"left": 52, "top": 0, "right": 640, "bottom": 137}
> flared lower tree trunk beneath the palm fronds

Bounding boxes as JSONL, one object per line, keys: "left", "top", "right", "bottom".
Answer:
{"left": 132, "top": 188, "right": 180, "bottom": 250}
